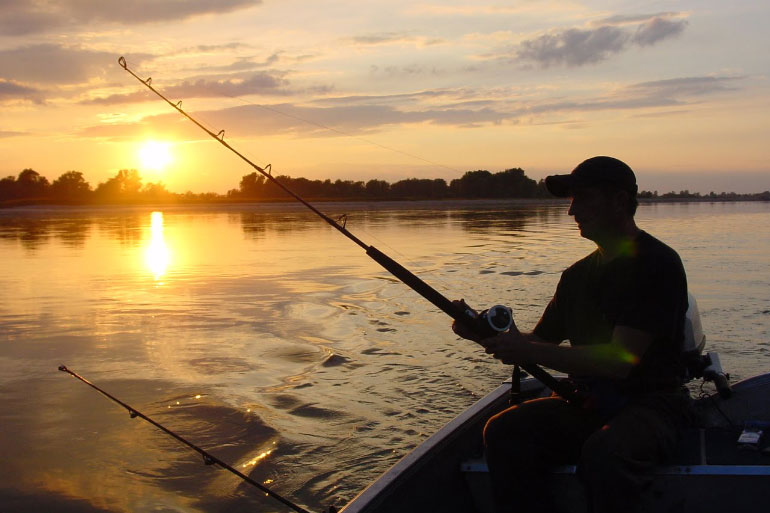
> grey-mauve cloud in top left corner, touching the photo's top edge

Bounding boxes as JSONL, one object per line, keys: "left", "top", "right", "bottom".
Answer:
{"left": 0, "top": 0, "right": 262, "bottom": 36}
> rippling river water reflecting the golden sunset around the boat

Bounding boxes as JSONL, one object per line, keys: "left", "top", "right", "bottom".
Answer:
{"left": 0, "top": 201, "right": 770, "bottom": 513}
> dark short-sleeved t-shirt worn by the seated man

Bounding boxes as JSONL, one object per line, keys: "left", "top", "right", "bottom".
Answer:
{"left": 534, "top": 231, "right": 687, "bottom": 394}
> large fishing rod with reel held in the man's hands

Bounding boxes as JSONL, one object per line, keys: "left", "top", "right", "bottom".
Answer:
{"left": 118, "top": 56, "right": 581, "bottom": 404}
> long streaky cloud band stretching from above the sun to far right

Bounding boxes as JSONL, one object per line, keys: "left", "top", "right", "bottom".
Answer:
{"left": 80, "top": 77, "right": 741, "bottom": 139}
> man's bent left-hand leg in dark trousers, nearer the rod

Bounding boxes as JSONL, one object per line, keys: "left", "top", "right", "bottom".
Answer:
{"left": 484, "top": 397, "right": 600, "bottom": 513}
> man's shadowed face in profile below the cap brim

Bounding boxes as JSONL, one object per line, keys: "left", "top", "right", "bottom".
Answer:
{"left": 569, "top": 187, "right": 619, "bottom": 243}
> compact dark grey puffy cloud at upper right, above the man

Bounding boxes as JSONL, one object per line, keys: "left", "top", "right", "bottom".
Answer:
{"left": 513, "top": 13, "right": 687, "bottom": 68}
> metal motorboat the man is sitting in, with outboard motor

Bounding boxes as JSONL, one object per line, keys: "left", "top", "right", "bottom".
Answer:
{"left": 340, "top": 296, "right": 770, "bottom": 513}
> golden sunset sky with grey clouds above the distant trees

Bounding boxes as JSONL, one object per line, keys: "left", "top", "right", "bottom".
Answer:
{"left": 0, "top": 0, "right": 770, "bottom": 193}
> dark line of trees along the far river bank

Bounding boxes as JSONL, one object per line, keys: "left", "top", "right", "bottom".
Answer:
{"left": 0, "top": 168, "right": 770, "bottom": 206}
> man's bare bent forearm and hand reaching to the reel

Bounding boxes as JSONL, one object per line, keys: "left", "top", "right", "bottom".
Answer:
{"left": 478, "top": 326, "right": 652, "bottom": 378}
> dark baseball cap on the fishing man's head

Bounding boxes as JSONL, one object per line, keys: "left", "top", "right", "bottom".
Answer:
{"left": 545, "top": 156, "right": 638, "bottom": 198}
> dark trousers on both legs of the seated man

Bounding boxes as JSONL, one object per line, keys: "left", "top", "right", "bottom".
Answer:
{"left": 484, "top": 391, "right": 691, "bottom": 513}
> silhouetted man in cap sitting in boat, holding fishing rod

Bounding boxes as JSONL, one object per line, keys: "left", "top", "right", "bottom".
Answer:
{"left": 453, "top": 156, "right": 690, "bottom": 513}
